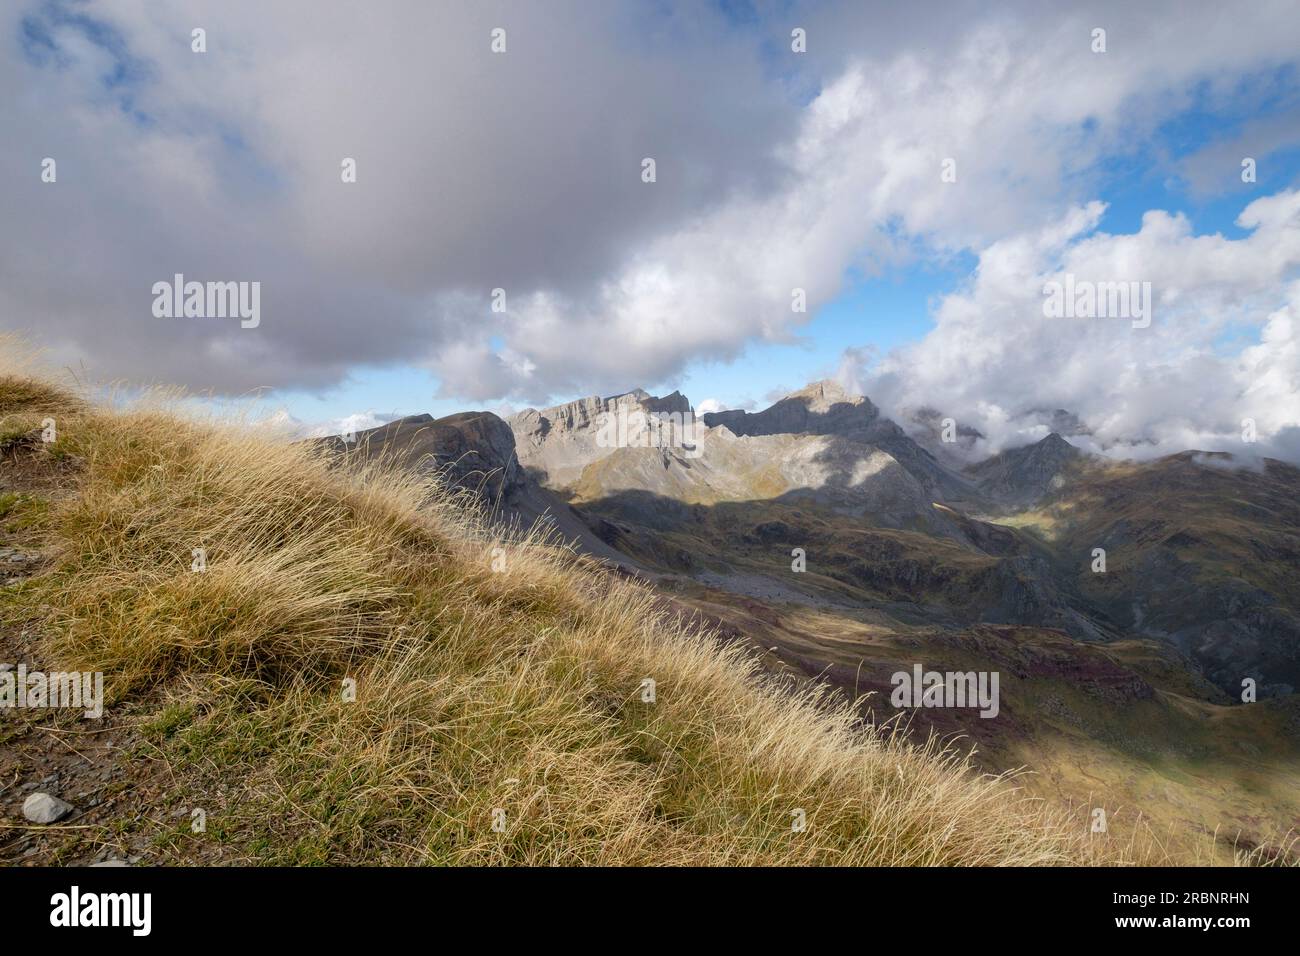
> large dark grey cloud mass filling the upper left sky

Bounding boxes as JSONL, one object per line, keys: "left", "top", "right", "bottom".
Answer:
{"left": 0, "top": 1, "right": 797, "bottom": 392}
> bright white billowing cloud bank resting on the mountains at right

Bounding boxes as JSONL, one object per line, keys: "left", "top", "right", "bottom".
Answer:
{"left": 850, "top": 191, "right": 1300, "bottom": 457}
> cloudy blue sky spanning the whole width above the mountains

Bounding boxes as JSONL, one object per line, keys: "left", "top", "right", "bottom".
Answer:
{"left": 0, "top": 0, "right": 1300, "bottom": 460}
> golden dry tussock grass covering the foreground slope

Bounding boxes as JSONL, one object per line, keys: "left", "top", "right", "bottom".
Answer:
{"left": 0, "top": 345, "right": 1149, "bottom": 865}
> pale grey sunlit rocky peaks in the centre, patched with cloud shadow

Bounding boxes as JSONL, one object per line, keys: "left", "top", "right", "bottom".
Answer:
{"left": 510, "top": 382, "right": 971, "bottom": 536}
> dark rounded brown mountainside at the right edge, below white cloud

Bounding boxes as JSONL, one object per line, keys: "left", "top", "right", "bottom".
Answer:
{"left": 1050, "top": 451, "right": 1300, "bottom": 701}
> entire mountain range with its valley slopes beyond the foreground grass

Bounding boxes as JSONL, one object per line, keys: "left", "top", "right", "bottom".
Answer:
{"left": 334, "top": 381, "right": 1300, "bottom": 858}
